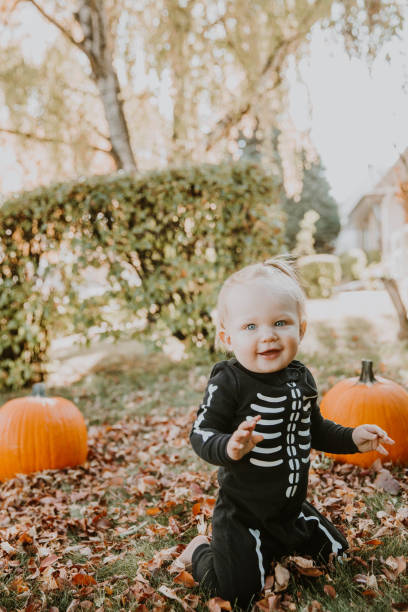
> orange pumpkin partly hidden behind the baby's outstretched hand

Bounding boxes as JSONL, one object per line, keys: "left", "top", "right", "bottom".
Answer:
{"left": 320, "top": 360, "right": 408, "bottom": 467}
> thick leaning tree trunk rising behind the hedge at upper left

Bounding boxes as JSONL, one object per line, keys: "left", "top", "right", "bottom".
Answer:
{"left": 76, "top": 0, "right": 136, "bottom": 171}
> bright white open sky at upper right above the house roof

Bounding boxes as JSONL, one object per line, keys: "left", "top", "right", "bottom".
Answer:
{"left": 291, "top": 28, "right": 408, "bottom": 210}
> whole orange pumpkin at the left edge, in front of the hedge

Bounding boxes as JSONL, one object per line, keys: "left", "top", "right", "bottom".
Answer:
{"left": 0, "top": 383, "right": 88, "bottom": 480}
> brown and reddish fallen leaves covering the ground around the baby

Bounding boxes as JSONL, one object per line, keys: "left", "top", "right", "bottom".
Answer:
{"left": 0, "top": 408, "right": 408, "bottom": 612}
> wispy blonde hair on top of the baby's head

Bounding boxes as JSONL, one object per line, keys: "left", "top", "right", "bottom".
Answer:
{"left": 215, "top": 256, "right": 306, "bottom": 349}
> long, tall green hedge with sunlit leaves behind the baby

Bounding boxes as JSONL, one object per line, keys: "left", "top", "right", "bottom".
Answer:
{"left": 0, "top": 164, "right": 284, "bottom": 387}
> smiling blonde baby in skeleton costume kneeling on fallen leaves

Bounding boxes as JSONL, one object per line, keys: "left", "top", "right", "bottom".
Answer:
{"left": 179, "top": 259, "right": 393, "bottom": 607}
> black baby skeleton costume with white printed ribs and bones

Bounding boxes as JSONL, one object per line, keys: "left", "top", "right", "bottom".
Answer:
{"left": 190, "top": 359, "right": 358, "bottom": 607}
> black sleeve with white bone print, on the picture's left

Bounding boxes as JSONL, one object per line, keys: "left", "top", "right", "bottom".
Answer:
{"left": 190, "top": 364, "right": 238, "bottom": 466}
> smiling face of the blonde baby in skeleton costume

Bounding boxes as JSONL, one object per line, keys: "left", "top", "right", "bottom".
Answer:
{"left": 220, "top": 279, "right": 306, "bottom": 373}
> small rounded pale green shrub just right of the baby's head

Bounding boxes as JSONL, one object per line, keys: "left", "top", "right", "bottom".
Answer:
{"left": 296, "top": 255, "right": 341, "bottom": 298}
